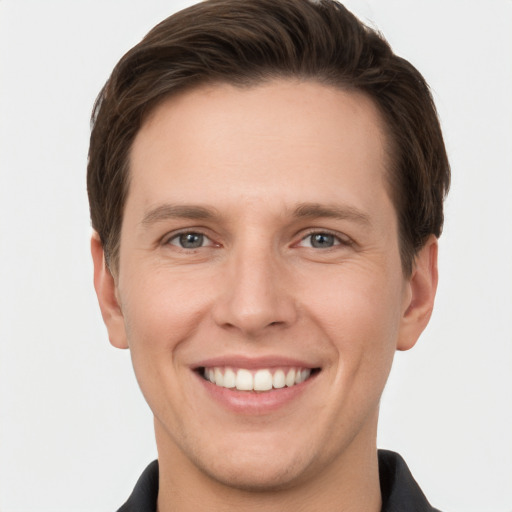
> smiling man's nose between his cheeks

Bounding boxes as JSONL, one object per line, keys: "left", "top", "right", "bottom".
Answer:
{"left": 213, "top": 243, "right": 298, "bottom": 338}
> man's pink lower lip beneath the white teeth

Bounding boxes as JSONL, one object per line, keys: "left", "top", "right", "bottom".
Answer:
{"left": 196, "top": 373, "right": 318, "bottom": 415}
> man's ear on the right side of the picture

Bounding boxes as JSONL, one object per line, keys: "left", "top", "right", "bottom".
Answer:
{"left": 397, "top": 235, "right": 438, "bottom": 350}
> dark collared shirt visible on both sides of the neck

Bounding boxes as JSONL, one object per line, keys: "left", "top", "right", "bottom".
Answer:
{"left": 117, "top": 450, "right": 439, "bottom": 512}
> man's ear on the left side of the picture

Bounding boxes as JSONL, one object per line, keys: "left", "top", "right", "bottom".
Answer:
{"left": 91, "top": 232, "right": 128, "bottom": 348}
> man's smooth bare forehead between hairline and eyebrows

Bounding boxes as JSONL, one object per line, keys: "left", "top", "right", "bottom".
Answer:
{"left": 128, "top": 80, "right": 387, "bottom": 222}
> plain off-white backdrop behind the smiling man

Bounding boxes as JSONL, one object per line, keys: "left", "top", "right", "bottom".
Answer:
{"left": 0, "top": 0, "right": 512, "bottom": 512}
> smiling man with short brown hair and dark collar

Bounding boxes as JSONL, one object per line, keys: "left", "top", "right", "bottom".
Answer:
{"left": 88, "top": 0, "right": 449, "bottom": 512}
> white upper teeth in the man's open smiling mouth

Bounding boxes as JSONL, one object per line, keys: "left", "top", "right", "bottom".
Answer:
{"left": 198, "top": 366, "right": 320, "bottom": 392}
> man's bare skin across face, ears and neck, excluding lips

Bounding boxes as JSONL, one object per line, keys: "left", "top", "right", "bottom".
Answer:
{"left": 92, "top": 80, "right": 437, "bottom": 512}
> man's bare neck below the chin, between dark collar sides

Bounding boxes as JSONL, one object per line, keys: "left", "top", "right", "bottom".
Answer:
{"left": 155, "top": 421, "right": 381, "bottom": 512}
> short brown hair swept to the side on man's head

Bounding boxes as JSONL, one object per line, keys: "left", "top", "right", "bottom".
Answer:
{"left": 87, "top": 0, "right": 450, "bottom": 274}
